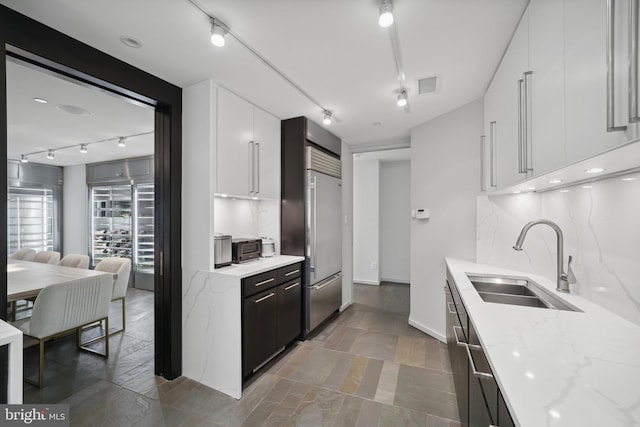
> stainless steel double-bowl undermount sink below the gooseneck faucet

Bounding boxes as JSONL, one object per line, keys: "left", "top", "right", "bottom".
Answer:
{"left": 467, "top": 274, "right": 582, "bottom": 311}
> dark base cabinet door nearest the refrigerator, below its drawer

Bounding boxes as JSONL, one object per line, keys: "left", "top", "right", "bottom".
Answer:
{"left": 277, "top": 278, "right": 302, "bottom": 348}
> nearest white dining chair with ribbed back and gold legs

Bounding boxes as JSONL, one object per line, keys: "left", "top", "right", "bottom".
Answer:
{"left": 15, "top": 274, "right": 112, "bottom": 388}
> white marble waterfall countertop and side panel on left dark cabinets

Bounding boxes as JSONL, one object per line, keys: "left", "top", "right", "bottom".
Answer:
{"left": 182, "top": 255, "right": 304, "bottom": 399}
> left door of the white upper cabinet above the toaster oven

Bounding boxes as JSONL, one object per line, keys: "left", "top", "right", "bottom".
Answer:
{"left": 216, "top": 88, "right": 254, "bottom": 201}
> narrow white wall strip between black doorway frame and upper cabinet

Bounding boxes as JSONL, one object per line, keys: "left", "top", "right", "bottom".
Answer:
{"left": 182, "top": 80, "right": 216, "bottom": 270}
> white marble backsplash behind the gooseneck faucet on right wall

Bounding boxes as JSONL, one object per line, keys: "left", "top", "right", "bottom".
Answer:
{"left": 476, "top": 173, "right": 640, "bottom": 324}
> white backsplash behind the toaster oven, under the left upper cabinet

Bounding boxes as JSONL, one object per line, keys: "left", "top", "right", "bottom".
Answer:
{"left": 213, "top": 197, "right": 280, "bottom": 254}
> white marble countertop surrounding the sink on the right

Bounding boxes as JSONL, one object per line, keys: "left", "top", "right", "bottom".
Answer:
{"left": 446, "top": 258, "right": 640, "bottom": 427}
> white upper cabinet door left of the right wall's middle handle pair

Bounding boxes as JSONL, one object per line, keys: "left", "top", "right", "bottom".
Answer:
{"left": 493, "top": 7, "right": 529, "bottom": 188}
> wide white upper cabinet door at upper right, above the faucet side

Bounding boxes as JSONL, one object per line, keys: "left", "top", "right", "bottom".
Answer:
{"left": 564, "top": 0, "right": 637, "bottom": 163}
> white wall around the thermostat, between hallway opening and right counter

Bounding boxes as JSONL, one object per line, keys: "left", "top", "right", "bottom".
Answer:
{"left": 409, "top": 99, "right": 483, "bottom": 341}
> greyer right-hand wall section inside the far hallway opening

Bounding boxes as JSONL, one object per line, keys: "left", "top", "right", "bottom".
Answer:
{"left": 380, "top": 160, "right": 411, "bottom": 283}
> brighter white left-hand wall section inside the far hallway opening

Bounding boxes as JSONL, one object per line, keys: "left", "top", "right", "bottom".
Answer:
{"left": 353, "top": 159, "right": 380, "bottom": 285}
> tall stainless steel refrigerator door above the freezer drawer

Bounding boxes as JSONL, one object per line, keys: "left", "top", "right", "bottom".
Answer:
{"left": 308, "top": 171, "right": 342, "bottom": 285}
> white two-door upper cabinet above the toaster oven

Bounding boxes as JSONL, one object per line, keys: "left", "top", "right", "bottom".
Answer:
{"left": 216, "top": 88, "right": 280, "bottom": 199}
